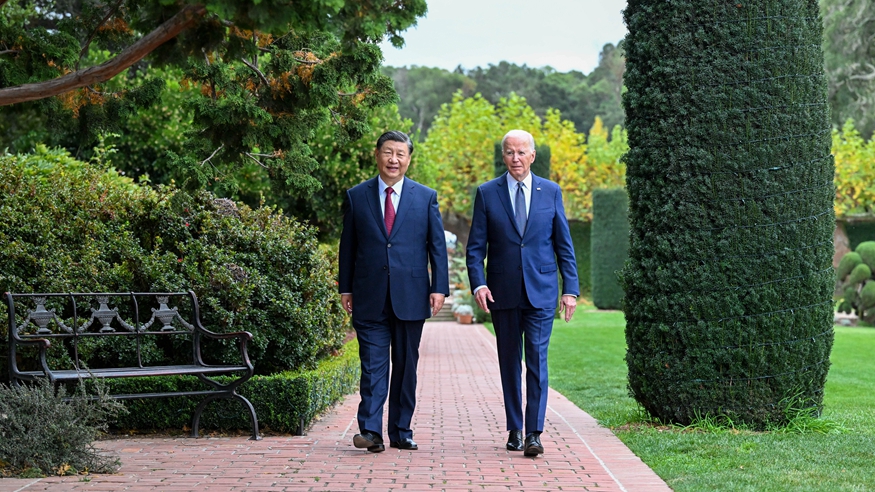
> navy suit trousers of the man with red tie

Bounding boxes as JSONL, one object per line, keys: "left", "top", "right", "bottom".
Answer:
{"left": 352, "top": 284, "right": 425, "bottom": 441}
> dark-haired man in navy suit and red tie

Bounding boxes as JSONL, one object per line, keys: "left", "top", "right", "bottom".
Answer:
{"left": 338, "top": 131, "right": 450, "bottom": 453}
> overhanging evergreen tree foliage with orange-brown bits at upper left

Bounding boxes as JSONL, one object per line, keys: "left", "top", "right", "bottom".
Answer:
{"left": 0, "top": 0, "right": 426, "bottom": 193}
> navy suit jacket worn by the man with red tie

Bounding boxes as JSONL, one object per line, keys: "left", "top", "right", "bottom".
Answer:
{"left": 338, "top": 178, "right": 450, "bottom": 321}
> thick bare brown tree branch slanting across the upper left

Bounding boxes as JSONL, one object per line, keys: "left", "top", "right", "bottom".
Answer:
{"left": 0, "top": 4, "right": 207, "bottom": 106}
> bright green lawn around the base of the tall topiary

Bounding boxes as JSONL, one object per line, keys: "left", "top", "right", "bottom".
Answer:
{"left": 549, "top": 307, "right": 875, "bottom": 492}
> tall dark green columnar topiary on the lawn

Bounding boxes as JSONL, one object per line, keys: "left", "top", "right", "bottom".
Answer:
{"left": 622, "top": 0, "right": 835, "bottom": 428}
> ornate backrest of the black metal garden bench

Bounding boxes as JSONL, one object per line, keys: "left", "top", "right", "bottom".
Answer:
{"left": 6, "top": 291, "right": 204, "bottom": 374}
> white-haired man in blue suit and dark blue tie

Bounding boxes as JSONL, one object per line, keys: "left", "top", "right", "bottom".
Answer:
{"left": 467, "top": 130, "right": 580, "bottom": 456}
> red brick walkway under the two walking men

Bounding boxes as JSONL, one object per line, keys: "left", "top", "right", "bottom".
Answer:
{"left": 0, "top": 322, "right": 670, "bottom": 492}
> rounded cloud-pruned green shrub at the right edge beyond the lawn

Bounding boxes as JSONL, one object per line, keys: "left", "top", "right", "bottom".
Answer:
{"left": 836, "top": 241, "right": 875, "bottom": 322}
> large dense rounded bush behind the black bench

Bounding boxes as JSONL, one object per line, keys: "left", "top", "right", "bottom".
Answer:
{"left": 0, "top": 147, "right": 346, "bottom": 374}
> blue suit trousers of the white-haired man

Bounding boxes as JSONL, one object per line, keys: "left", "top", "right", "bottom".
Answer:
{"left": 492, "top": 288, "right": 555, "bottom": 434}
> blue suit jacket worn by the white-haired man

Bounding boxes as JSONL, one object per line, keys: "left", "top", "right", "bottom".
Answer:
{"left": 467, "top": 173, "right": 580, "bottom": 309}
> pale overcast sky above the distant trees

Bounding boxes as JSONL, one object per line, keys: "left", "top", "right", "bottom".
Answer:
{"left": 381, "top": 0, "right": 626, "bottom": 74}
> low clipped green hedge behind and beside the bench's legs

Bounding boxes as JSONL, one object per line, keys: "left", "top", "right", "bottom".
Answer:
{"left": 106, "top": 340, "right": 360, "bottom": 433}
